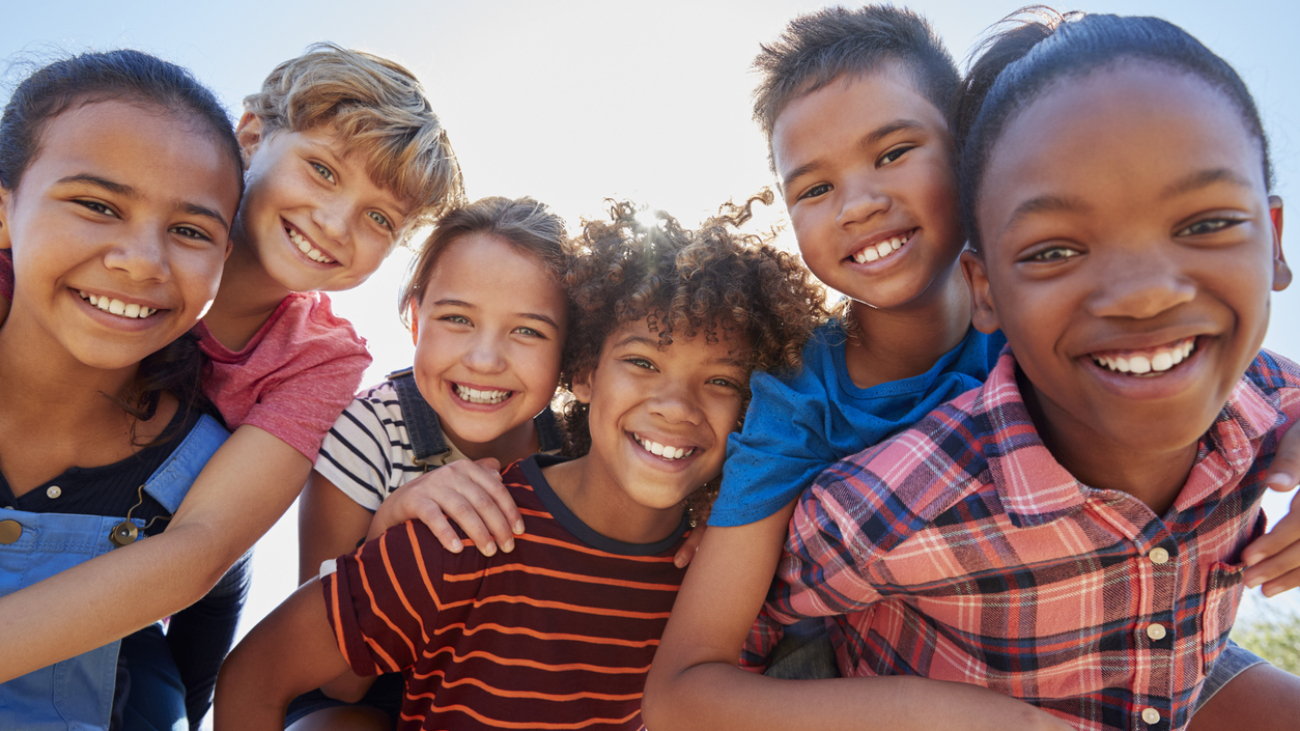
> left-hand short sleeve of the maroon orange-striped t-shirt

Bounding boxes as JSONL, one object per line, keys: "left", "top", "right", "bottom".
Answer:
{"left": 321, "top": 522, "right": 443, "bottom": 675}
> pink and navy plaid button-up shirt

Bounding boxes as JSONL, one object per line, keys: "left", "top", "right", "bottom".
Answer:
{"left": 744, "top": 352, "right": 1300, "bottom": 731}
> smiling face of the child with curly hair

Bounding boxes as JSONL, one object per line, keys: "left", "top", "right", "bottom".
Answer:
{"left": 573, "top": 320, "right": 749, "bottom": 511}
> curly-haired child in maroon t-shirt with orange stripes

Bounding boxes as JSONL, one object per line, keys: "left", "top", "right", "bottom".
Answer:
{"left": 217, "top": 195, "right": 820, "bottom": 730}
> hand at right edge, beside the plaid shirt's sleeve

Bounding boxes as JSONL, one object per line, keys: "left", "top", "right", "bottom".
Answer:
{"left": 1242, "top": 428, "right": 1300, "bottom": 597}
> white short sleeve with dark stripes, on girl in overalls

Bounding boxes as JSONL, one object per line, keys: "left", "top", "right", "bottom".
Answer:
{"left": 316, "top": 386, "right": 402, "bottom": 512}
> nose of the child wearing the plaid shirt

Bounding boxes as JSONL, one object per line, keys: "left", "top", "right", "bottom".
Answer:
{"left": 1087, "top": 246, "right": 1196, "bottom": 320}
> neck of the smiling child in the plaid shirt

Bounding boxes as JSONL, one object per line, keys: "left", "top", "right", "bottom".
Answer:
{"left": 1017, "top": 372, "right": 1197, "bottom": 515}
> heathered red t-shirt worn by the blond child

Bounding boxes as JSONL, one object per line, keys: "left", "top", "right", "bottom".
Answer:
{"left": 196, "top": 291, "right": 371, "bottom": 463}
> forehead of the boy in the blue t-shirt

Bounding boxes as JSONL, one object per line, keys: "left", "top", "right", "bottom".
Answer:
{"left": 772, "top": 60, "right": 949, "bottom": 177}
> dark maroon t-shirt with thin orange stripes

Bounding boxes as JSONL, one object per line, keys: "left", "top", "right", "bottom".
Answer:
{"left": 322, "top": 455, "right": 685, "bottom": 731}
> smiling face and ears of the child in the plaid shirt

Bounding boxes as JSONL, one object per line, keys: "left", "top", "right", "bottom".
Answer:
{"left": 963, "top": 64, "right": 1287, "bottom": 454}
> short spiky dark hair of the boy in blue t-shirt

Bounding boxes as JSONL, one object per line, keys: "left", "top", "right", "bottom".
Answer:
{"left": 754, "top": 5, "right": 961, "bottom": 167}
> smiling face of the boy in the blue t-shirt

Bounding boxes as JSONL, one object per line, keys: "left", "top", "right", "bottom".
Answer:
{"left": 772, "top": 64, "right": 963, "bottom": 308}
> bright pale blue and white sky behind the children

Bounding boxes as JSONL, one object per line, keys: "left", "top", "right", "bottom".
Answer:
{"left": 0, "top": 0, "right": 1300, "bottom": 707}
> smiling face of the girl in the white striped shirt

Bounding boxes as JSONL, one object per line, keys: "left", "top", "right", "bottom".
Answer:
{"left": 411, "top": 233, "right": 568, "bottom": 449}
